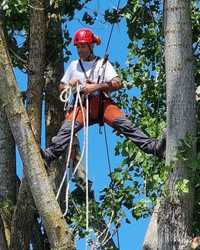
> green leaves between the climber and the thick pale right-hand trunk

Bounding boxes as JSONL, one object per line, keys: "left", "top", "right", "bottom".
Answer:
{"left": 109, "top": 0, "right": 168, "bottom": 224}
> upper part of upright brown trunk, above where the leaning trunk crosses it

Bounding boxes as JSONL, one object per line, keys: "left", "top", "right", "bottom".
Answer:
{"left": 26, "top": 0, "right": 46, "bottom": 144}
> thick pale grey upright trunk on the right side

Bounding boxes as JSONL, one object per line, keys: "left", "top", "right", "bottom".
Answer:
{"left": 158, "top": 0, "right": 196, "bottom": 250}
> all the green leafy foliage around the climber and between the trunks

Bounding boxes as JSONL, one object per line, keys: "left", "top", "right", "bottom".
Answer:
{"left": 2, "top": 0, "right": 200, "bottom": 244}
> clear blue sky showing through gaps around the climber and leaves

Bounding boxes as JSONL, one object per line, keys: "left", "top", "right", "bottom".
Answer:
{"left": 15, "top": 0, "right": 149, "bottom": 250}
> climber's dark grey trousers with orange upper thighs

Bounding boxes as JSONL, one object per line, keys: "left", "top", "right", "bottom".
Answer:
{"left": 44, "top": 96, "right": 159, "bottom": 162}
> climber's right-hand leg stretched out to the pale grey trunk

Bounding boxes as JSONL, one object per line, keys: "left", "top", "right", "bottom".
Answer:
{"left": 104, "top": 100, "right": 166, "bottom": 158}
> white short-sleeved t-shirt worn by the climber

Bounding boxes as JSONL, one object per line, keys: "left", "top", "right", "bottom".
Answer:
{"left": 61, "top": 59, "right": 118, "bottom": 95}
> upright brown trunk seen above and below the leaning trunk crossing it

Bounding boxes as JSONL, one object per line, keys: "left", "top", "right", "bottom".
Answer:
{"left": 11, "top": 0, "right": 46, "bottom": 250}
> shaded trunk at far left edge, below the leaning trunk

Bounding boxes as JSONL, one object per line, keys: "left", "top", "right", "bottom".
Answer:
{"left": 0, "top": 12, "right": 16, "bottom": 249}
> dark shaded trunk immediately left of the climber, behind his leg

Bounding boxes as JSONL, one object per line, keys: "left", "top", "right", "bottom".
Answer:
{"left": 45, "top": 19, "right": 65, "bottom": 207}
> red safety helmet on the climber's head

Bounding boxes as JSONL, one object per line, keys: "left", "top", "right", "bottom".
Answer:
{"left": 74, "top": 29, "right": 101, "bottom": 46}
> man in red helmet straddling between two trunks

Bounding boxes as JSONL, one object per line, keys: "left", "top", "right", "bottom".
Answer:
{"left": 42, "top": 29, "right": 165, "bottom": 165}
